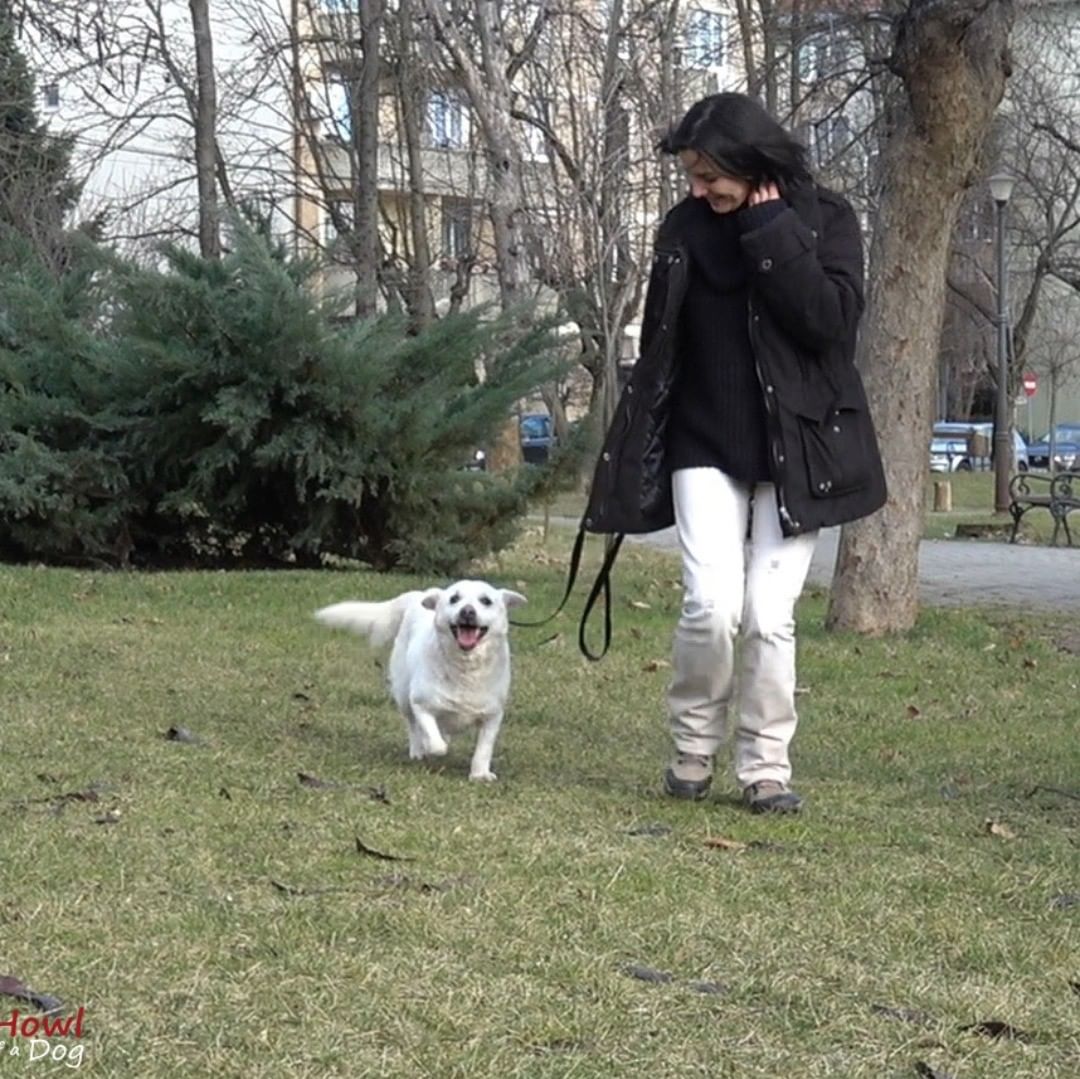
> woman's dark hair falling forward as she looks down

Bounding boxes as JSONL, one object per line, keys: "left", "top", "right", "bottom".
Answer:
{"left": 660, "top": 94, "right": 810, "bottom": 187}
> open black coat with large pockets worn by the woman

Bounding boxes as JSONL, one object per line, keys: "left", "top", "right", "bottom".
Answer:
{"left": 583, "top": 184, "right": 886, "bottom": 544}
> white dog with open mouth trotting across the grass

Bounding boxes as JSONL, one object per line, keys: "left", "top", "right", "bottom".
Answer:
{"left": 315, "top": 581, "right": 526, "bottom": 780}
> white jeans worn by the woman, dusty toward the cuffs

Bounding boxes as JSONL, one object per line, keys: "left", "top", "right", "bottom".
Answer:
{"left": 667, "top": 468, "right": 818, "bottom": 787}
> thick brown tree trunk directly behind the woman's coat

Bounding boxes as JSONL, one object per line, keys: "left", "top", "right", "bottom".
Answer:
{"left": 827, "top": 0, "right": 1013, "bottom": 634}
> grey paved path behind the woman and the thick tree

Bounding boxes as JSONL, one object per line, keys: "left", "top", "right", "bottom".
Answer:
{"left": 633, "top": 528, "right": 1080, "bottom": 613}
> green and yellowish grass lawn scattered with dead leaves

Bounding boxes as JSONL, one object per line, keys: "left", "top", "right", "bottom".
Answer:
{"left": 0, "top": 531, "right": 1080, "bottom": 1079}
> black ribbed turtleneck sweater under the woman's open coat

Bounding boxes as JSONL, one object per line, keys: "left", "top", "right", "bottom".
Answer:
{"left": 666, "top": 199, "right": 787, "bottom": 483}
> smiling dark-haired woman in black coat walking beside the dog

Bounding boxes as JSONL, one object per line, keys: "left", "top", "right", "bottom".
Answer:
{"left": 584, "top": 94, "right": 886, "bottom": 812}
